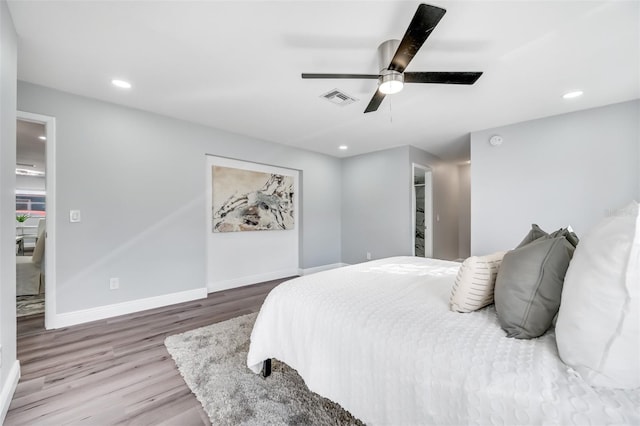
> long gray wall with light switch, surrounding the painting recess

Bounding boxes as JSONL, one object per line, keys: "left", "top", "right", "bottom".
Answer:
{"left": 18, "top": 82, "right": 341, "bottom": 313}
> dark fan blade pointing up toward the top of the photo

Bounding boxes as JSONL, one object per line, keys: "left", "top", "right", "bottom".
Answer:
{"left": 389, "top": 3, "right": 447, "bottom": 72}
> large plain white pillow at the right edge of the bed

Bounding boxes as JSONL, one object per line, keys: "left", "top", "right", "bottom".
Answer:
{"left": 556, "top": 201, "right": 640, "bottom": 389}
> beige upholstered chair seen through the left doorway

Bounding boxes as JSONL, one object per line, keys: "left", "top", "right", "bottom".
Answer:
{"left": 16, "top": 219, "right": 46, "bottom": 296}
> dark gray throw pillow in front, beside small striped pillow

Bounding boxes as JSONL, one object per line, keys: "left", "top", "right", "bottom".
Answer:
{"left": 494, "top": 236, "right": 575, "bottom": 339}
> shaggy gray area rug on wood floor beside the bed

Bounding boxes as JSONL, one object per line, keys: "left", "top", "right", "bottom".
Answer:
{"left": 165, "top": 314, "right": 363, "bottom": 425}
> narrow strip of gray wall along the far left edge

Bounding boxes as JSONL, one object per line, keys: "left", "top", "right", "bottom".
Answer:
{"left": 0, "top": 0, "right": 18, "bottom": 422}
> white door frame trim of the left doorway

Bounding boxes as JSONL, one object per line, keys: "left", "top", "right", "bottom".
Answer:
{"left": 16, "top": 111, "right": 56, "bottom": 330}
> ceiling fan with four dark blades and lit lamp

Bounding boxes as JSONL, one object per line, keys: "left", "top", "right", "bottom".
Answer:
{"left": 302, "top": 3, "right": 482, "bottom": 113}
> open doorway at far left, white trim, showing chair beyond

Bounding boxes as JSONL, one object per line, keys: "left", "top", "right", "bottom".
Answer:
{"left": 15, "top": 111, "right": 55, "bottom": 328}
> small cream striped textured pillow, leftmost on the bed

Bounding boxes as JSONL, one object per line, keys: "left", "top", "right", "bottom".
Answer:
{"left": 449, "top": 251, "right": 507, "bottom": 312}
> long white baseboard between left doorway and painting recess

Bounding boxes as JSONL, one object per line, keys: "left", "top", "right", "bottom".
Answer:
{"left": 52, "top": 288, "right": 207, "bottom": 328}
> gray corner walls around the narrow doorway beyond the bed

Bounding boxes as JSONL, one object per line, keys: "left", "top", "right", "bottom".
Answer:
{"left": 342, "top": 146, "right": 458, "bottom": 263}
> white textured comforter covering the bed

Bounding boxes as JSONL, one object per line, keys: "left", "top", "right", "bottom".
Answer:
{"left": 247, "top": 257, "right": 640, "bottom": 425}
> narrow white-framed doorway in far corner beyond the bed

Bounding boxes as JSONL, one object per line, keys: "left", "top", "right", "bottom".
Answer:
{"left": 412, "top": 164, "right": 433, "bottom": 257}
